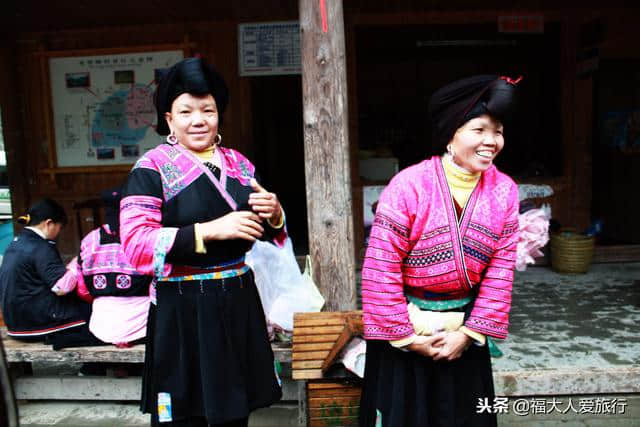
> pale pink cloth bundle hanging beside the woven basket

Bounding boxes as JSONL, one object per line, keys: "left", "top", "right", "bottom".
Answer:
{"left": 516, "top": 205, "right": 551, "bottom": 271}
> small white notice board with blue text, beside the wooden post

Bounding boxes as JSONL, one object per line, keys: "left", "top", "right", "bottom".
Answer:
{"left": 238, "top": 21, "right": 302, "bottom": 76}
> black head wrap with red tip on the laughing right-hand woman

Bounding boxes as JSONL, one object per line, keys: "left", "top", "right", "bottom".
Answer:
{"left": 429, "top": 74, "right": 522, "bottom": 155}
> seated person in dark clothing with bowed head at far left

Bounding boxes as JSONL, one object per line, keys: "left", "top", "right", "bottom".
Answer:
{"left": 0, "top": 199, "right": 103, "bottom": 349}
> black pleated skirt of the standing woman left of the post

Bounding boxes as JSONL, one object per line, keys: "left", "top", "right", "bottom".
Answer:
{"left": 141, "top": 271, "right": 282, "bottom": 424}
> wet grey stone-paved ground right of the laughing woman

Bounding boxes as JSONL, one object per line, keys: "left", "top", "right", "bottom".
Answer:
{"left": 494, "top": 263, "right": 640, "bottom": 370}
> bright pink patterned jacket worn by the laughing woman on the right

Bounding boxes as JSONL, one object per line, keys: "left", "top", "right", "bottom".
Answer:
{"left": 362, "top": 157, "right": 519, "bottom": 340}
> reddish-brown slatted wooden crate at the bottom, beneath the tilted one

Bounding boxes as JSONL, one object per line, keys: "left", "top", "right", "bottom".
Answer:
{"left": 307, "top": 380, "right": 362, "bottom": 427}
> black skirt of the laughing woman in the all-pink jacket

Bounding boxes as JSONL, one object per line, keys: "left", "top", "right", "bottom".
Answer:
{"left": 359, "top": 340, "right": 496, "bottom": 427}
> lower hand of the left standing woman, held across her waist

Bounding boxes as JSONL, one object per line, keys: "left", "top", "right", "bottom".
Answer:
{"left": 199, "top": 211, "right": 264, "bottom": 242}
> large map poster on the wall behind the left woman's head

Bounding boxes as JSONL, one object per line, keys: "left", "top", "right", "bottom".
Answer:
{"left": 49, "top": 50, "right": 184, "bottom": 167}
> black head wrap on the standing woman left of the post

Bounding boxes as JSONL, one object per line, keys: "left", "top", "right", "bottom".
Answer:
{"left": 153, "top": 58, "right": 229, "bottom": 135}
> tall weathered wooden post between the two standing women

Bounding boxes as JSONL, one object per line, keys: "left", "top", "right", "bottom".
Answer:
{"left": 299, "top": 0, "right": 356, "bottom": 311}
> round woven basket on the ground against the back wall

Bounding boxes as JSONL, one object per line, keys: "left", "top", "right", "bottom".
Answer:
{"left": 551, "top": 228, "right": 595, "bottom": 273}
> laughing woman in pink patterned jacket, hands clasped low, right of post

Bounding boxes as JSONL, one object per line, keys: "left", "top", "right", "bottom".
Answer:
{"left": 360, "top": 75, "right": 519, "bottom": 427}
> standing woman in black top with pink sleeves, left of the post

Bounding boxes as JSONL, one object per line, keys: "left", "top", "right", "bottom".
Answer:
{"left": 120, "top": 58, "right": 286, "bottom": 426}
